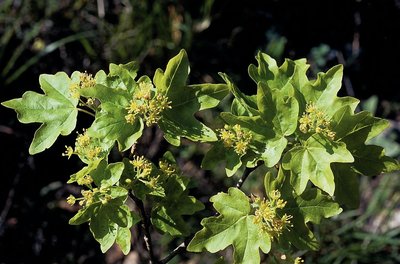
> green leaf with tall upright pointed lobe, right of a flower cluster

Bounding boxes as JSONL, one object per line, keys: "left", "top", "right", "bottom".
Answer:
{"left": 153, "top": 50, "right": 228, "bottom": 146}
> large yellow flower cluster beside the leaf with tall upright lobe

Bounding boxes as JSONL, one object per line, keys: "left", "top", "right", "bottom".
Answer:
{"left": 125, "top": 82, "right": 171, "bottom": 126}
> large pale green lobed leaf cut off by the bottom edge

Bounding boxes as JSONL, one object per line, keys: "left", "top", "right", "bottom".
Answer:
{"left": 187, "top": 188, "right": 271, "bottom": 263}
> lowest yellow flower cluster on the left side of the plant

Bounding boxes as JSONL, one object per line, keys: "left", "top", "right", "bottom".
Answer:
{"left": 67, "top": 186, "right": 112, "bottom": 207}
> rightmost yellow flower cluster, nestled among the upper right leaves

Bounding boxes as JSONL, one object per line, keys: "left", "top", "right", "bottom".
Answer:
{"left": 299, "top": 103, "right": 336, "bottom": 140}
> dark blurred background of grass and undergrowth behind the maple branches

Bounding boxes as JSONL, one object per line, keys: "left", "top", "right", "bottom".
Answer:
{"left": 0, "top": 0, "right": 400, "bottom": 263}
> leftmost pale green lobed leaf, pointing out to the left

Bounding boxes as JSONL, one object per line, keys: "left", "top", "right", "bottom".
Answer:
{"left": 2, "top": 72, "right": 79, "bottom": 154}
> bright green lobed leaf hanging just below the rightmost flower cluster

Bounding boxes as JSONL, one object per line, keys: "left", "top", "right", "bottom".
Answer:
{"left": 282, "top": 134, "right": 354, "bottom": 195}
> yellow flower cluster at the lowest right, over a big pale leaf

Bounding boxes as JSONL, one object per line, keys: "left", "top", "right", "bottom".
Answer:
{"left": 253, "top": 190, "right": 293, "bottom": 238}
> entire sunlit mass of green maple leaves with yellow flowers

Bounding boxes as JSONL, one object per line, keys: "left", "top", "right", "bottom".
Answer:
{"left": 2, "top": 50, "right": 399, "bottom": 263}
